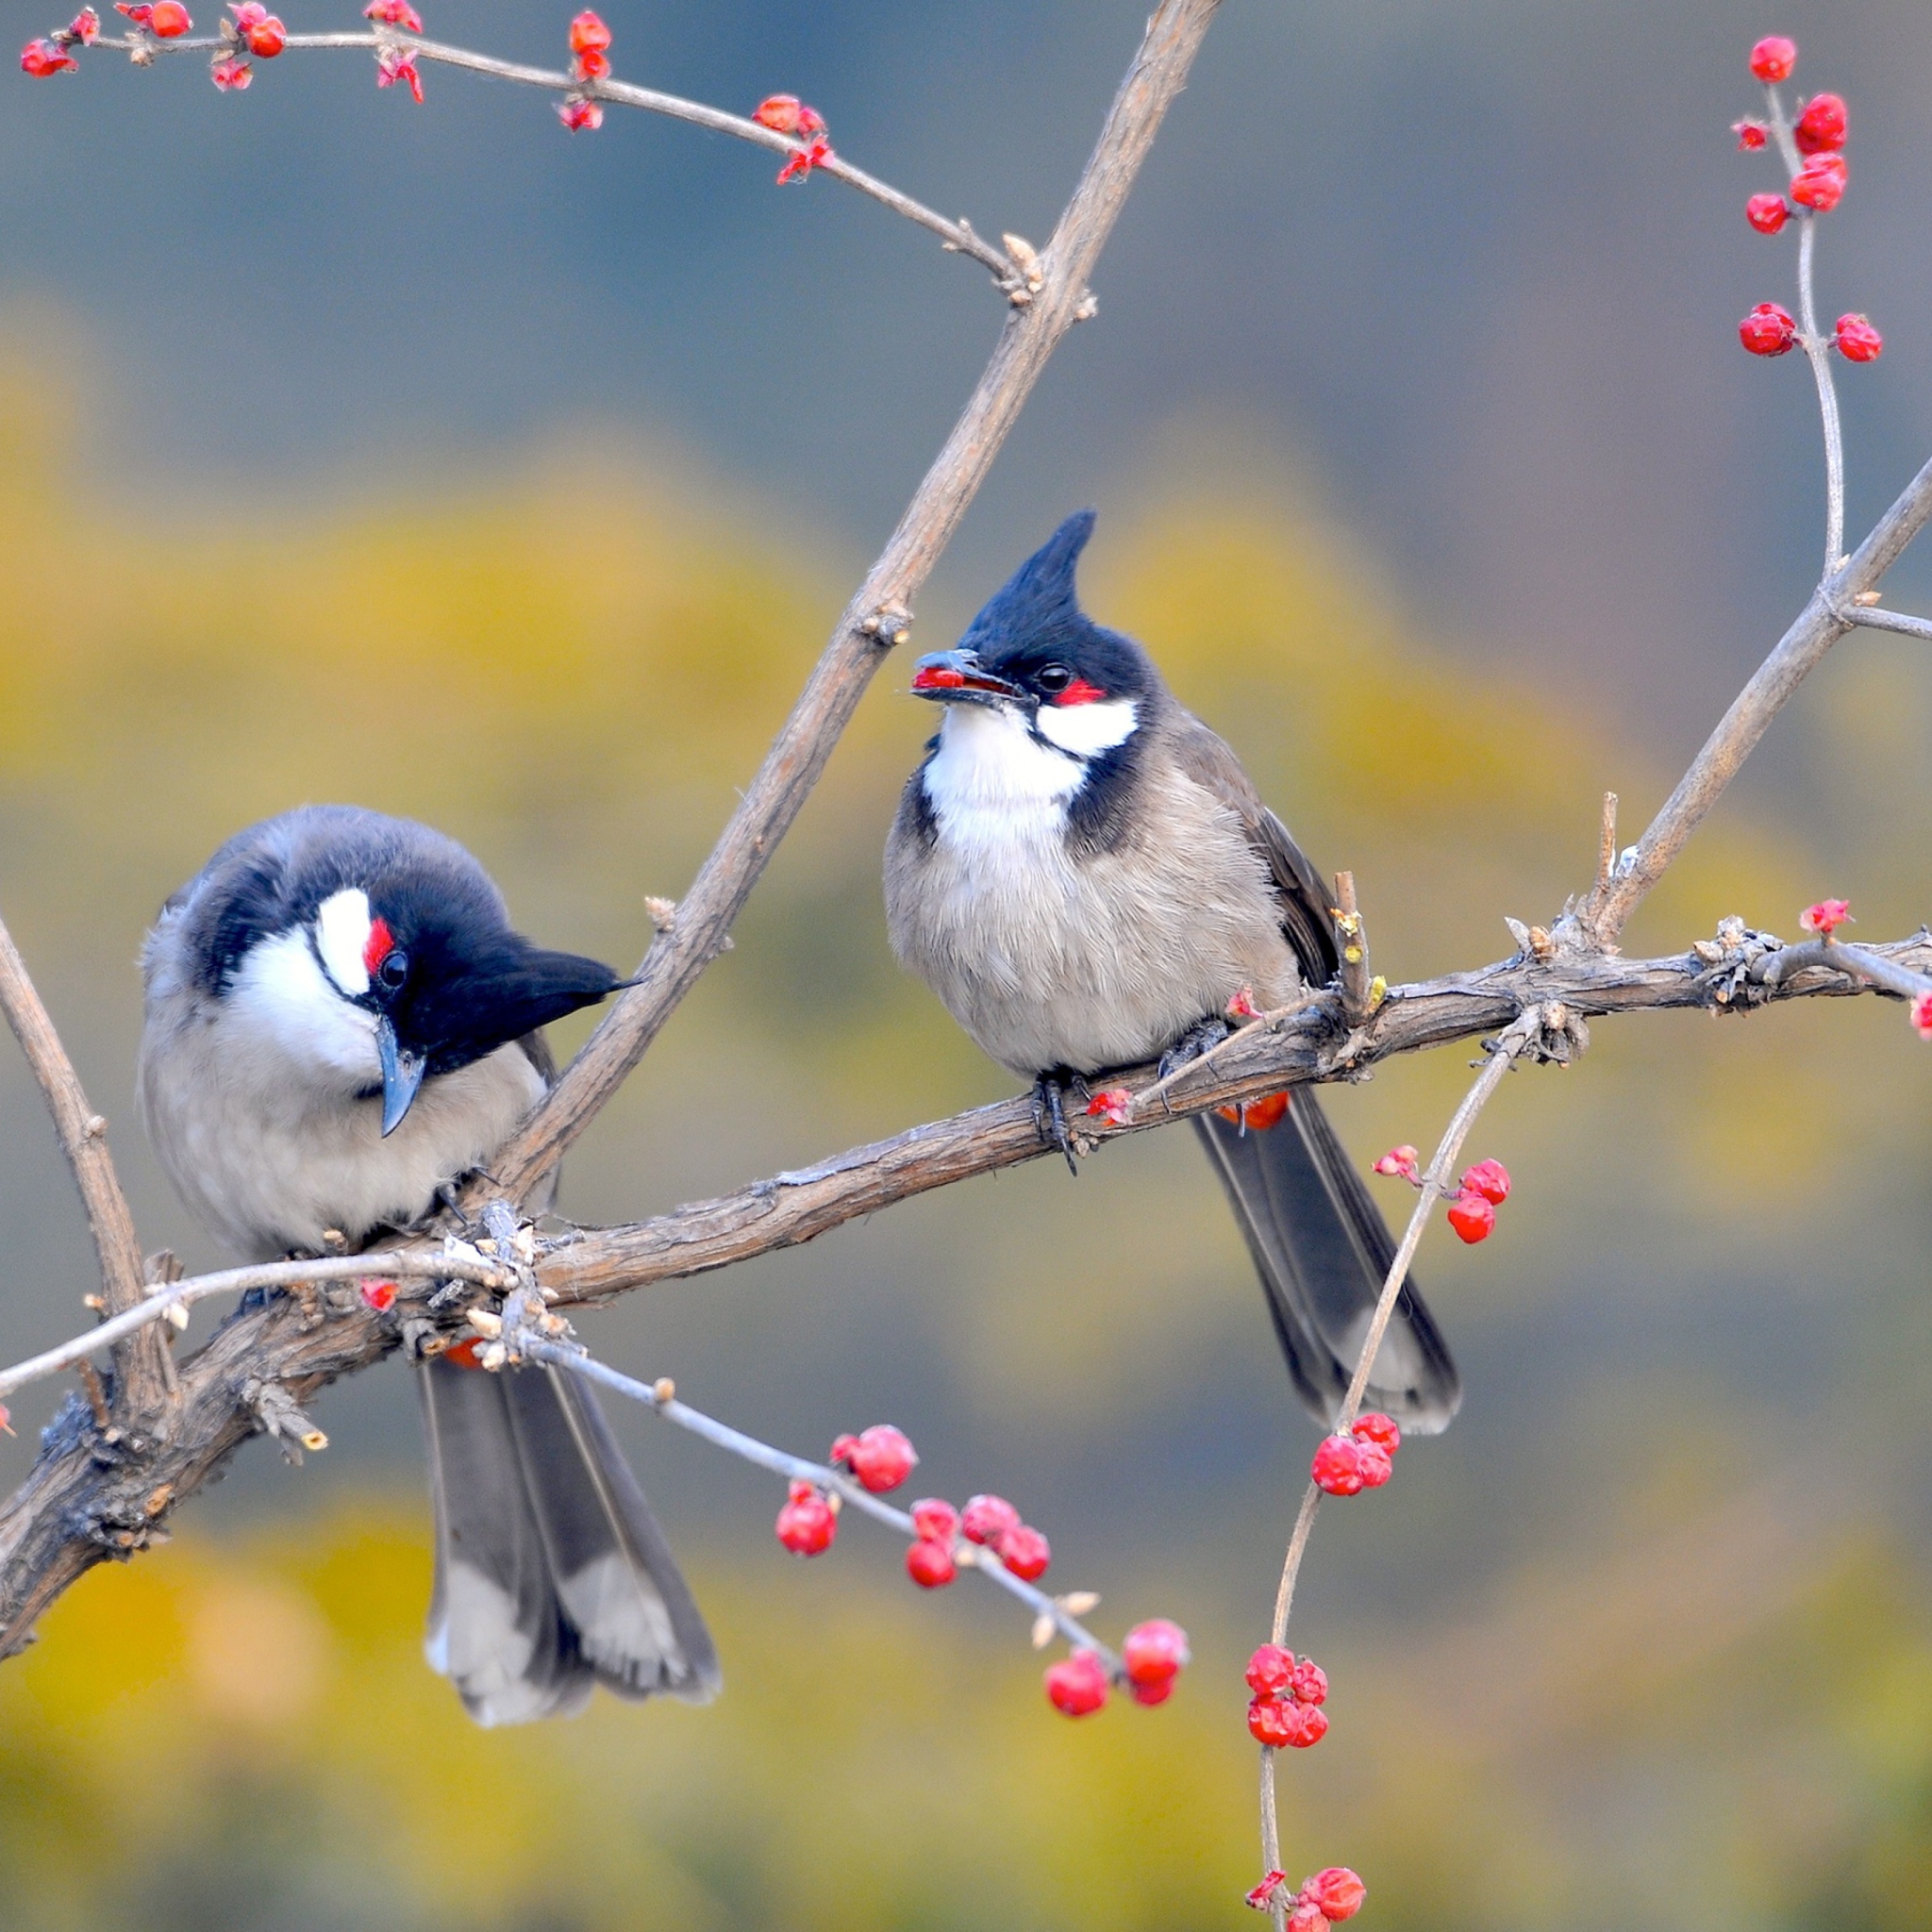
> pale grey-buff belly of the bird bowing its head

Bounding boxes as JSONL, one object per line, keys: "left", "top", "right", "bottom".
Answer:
{"left": 143, "top": 1045, "right": 542, "bottom": 1257}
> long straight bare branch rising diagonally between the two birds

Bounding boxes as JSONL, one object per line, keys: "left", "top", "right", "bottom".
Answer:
{"left": 494, "top": 0, "right": 1219, "bottom": 1200}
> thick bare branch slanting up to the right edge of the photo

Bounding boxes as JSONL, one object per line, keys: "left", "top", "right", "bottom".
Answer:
{"left": 1576, "top": 444, "right": 1932, "bottom": 947}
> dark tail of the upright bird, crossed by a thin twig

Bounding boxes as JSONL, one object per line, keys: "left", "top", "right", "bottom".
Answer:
{"left": 1194, "top": 1088, "right": 1462, "bottom": 1436}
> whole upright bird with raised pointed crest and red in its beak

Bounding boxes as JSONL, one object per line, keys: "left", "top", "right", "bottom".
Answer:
{"left": 885, "top": 510, "right": 1460, "bottom": 1434}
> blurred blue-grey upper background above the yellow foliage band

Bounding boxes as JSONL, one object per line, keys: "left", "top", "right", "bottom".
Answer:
{"left": 11, "top": 0, "right": 1932, "bottom": 754}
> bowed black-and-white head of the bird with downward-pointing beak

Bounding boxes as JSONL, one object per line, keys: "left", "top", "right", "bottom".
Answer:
{"left": 205, "top": 808, "right": 622, "bottom": 1136}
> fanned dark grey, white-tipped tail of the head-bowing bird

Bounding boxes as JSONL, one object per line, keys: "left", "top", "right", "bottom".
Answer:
{"left": 419, "top": 1357, "right": 721, "bottom": 1724}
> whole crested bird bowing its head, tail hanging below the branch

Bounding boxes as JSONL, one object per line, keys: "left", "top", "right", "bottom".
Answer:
{"left": 135, "top": 806, "right": 721, "bottom": 1725}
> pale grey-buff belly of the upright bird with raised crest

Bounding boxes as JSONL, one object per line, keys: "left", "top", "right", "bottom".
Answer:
{"left": 889, "top": 835, "right": 1298, "bottom": 1074}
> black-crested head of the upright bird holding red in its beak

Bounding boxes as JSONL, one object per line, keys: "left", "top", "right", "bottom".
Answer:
{"left": 912, "top": 510, "right": 1161, "bottom": 761}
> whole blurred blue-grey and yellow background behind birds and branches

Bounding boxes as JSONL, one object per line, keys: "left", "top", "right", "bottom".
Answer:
{"left": 0, "top": 0, "right": 1932, "bottom": 1932}
